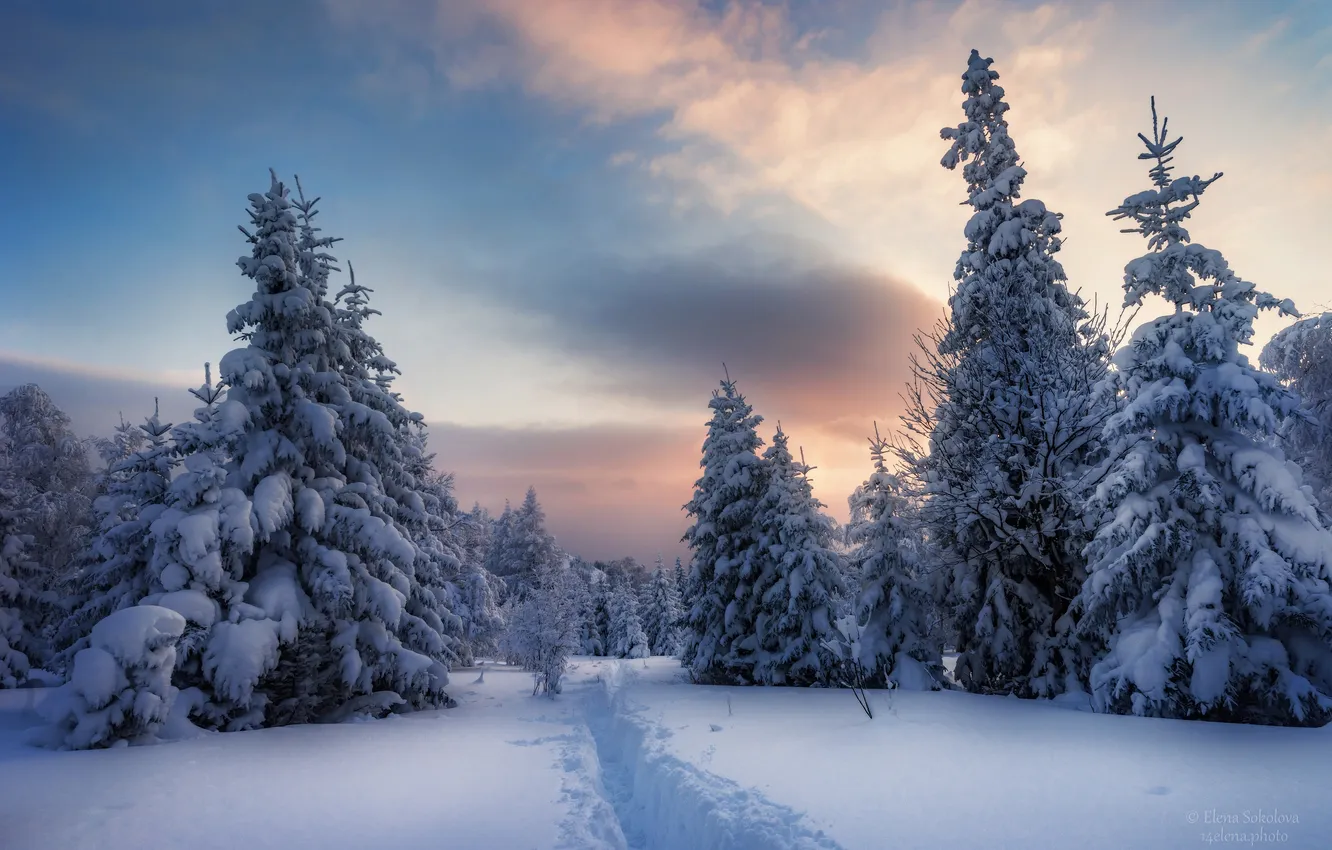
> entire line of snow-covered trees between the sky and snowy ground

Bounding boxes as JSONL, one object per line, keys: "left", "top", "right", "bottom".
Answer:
{"left": 0, "top": 51, "right": 1332, "bottom": 767}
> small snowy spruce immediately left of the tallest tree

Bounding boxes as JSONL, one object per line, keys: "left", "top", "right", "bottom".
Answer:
{"left": 846, "top": 428, "right": 943, "bottom": 690}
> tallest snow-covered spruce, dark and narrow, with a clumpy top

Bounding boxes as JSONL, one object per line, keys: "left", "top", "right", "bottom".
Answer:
{"left": 902, "top": 51, "right": 1108, "bottom": 697}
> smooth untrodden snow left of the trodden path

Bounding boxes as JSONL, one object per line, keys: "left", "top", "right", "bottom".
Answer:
{"left": 0, "top": 667, "right": 583, "bottom": 850}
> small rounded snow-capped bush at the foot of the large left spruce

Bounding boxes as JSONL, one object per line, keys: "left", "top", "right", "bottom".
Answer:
{"left": 40, "top": 605, "right": 185, "bottom": 750}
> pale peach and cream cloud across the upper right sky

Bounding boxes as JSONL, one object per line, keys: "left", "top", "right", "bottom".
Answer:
{"left": 330, "top": 0, "right": 1332, "bottom": 327}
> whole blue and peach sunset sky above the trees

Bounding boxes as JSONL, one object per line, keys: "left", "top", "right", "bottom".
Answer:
{"left": 0, "top": 0, "right": 1332, "bottom": 562}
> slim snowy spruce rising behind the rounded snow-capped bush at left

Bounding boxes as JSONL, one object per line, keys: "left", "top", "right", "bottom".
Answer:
{"left": 53, "top": 405, "right": 176, "bottom": 669}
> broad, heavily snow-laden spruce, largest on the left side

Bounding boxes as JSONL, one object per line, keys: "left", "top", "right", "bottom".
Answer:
{"left": 149, "top": 176, "right": 449, "bottom": 729}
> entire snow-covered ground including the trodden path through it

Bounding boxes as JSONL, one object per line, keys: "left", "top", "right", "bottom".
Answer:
{"left": 0, "top": 658, "right": 1332, "bottom": 850}
